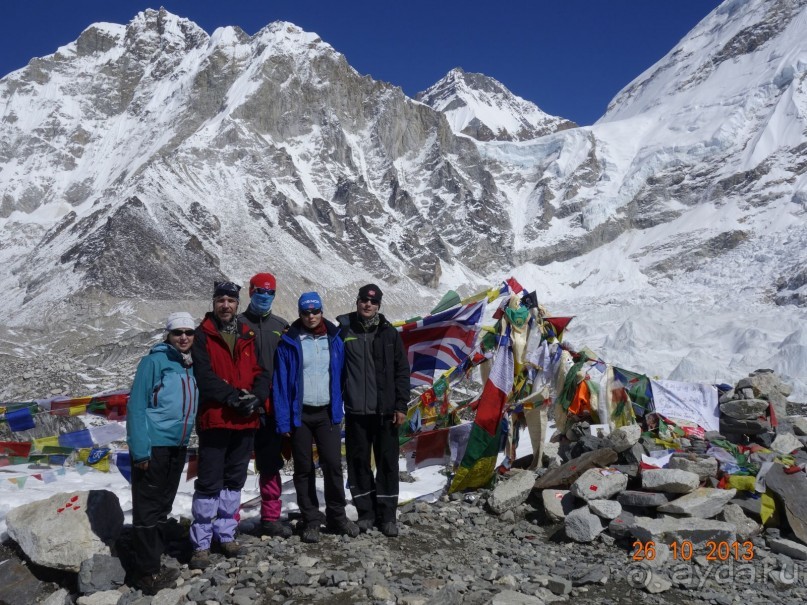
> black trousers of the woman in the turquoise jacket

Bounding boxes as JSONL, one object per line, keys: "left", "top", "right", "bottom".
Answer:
{"left": 132, "top": 446, "right": 187, "bottom": 574}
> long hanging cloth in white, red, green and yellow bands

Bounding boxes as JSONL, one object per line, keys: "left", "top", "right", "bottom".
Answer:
{"left": 449, "top": 337, "right": 513, "bottom": 492}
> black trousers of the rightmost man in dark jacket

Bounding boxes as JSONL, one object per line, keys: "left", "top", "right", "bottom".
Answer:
{"left": 345, "top": 414, "right": 400, "bottom": 524}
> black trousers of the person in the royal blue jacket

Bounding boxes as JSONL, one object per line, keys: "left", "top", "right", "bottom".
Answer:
{"left": 291, "top": 405, "right": 347, "bottom": 527}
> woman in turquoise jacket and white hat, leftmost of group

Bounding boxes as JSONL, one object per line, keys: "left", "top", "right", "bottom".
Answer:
{"left": 126, "top": 312, "right": 199, "bottom": 594}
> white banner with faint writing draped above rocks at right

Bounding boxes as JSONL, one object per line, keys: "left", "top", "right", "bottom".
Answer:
{"left": 650, "top": 380, "right": 720, "bottom": 431}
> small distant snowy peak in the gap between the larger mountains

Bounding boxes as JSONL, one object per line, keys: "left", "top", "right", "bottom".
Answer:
{"left": 416, "top": 67, "right": 576, "bottom": 141}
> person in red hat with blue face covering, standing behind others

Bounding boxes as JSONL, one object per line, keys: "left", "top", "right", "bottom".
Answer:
{"left": 238, "top": 273, "right": 291, "bottom": 538}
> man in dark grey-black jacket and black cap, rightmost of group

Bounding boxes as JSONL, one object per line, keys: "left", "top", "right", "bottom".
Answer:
{"left": 338, "top": 284, "right": 409, "bottom": 537}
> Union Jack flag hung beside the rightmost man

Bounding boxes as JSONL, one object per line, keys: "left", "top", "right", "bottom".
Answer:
{"left": 398, "top": 301, "right": 486, "bottom": 388}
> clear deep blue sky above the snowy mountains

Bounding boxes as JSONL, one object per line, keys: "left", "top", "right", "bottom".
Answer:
{"left": 0, "top": 0, "right": 720, "bottom": 125}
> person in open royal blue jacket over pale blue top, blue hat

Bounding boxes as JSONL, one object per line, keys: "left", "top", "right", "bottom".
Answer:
{"left": 273, "top": 292, "right": 359, "bottom": 542}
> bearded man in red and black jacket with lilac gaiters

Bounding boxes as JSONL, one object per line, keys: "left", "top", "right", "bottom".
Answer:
{"left": 189, "top": 282, "right": 271, "bottom": 569}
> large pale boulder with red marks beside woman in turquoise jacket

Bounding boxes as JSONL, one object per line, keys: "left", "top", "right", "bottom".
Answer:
{"left": 6, "top": 490, "right": 123, "bottom": 572}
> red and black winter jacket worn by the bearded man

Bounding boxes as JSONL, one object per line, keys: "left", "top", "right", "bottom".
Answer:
{"left": 192, "top": 313, "right": 271, "bottom": 430}
